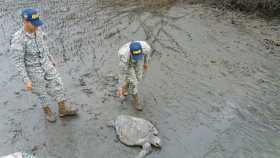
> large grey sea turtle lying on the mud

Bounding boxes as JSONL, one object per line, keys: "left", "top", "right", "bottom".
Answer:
{"left": 110, "top": 115, "right": 161, "bottom": 158}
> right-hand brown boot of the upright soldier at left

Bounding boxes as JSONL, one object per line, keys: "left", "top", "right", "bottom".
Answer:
{"left": 58, "top": 101, "right": 78, "bottom": 117}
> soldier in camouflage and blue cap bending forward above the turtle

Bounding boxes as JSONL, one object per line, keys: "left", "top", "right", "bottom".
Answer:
{"left": 117, "top": 41, "right": 151, "bottom": 111}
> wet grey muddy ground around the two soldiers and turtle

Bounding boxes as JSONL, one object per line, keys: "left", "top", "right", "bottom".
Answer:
{"left": 0, "top": 0, "right": 280, "bottom": 158}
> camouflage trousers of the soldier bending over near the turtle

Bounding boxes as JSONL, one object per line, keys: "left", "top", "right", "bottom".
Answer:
{"left": 124, "top": 62, "right": 144, "bottom": 95}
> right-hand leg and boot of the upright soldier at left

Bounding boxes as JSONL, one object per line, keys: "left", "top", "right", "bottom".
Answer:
{"left": 45, "top": 66, "right": 78, "bottom": 117}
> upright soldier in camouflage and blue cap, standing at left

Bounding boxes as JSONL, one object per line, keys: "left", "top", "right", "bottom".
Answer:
{"left": 11, "top": 9, "right": 78, "bottom": 122}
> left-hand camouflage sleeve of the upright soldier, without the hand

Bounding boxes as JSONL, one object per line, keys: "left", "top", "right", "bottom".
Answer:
{"left": 10, "top": 35, "right": 30, "bottom": 83}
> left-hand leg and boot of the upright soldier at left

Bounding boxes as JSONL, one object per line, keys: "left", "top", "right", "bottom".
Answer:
{"left": 27, "top": 68, "right": 56, "bottom": 122}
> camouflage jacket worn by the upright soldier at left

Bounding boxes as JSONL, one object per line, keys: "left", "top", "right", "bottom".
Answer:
{"left": 10, "top": 29, "right": 53, "bottom": 82}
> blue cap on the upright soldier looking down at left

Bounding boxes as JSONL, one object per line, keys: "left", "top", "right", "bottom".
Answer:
{"left": 21, "top": 8, "right": 43, "bottom": 26}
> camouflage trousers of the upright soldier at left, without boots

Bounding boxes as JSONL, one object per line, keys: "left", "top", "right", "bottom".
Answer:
{"left": 26, "top": 64, "right": 65, "bottom": 106}
